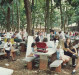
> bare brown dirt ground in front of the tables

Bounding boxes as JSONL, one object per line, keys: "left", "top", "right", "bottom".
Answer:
{"left": 0, "top": 52, "right": 79, "bottom": 75}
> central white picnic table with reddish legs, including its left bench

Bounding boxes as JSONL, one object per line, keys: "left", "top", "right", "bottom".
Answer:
{"left": 23, "top": 36, "right": 57, "bottom": 70}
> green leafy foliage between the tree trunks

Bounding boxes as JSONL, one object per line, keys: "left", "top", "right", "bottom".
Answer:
{"left": 0, "top": 0, "right": 79, "bottom": 28}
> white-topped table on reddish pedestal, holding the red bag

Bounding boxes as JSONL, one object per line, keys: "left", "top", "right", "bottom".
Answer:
{"left": 34, "top": 48, "right": 56, "bottom": 70}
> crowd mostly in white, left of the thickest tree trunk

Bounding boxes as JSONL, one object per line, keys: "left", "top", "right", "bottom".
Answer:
{"left": 0, "top": 31, "right": 28, "bottom": 61}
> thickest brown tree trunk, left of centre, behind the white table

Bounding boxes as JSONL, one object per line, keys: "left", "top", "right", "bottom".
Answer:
{"left": 24, "top": 0, "right": 32, "bottom": 35}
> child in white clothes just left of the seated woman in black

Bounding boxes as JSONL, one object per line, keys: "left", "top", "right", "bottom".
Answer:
{"left": 57, "top": 40, "right": 70, "bottom": 65}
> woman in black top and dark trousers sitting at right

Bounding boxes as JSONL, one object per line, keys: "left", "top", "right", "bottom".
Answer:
{"left": 64, "top": 38, "right": 77, "bottom": 67}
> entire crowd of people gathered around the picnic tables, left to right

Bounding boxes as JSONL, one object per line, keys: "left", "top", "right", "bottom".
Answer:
{"left": 0, "top": 30, "right": 79, "bottom": 74}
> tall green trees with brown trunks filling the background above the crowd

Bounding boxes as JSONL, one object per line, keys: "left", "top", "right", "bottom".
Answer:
{"left": 0, "top": 0, "right": 79, "bottom": 34}
